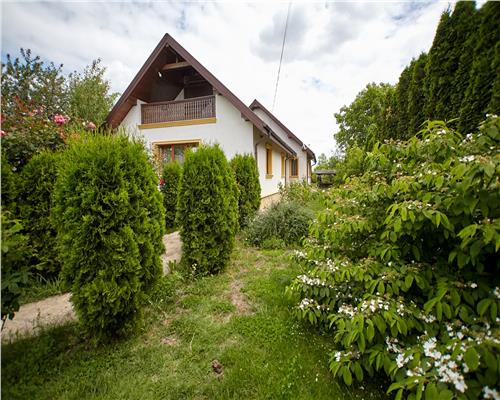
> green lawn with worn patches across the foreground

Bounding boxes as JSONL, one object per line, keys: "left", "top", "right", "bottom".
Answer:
{"left": 2, "top": 244, "right": 385, "bottom": 399}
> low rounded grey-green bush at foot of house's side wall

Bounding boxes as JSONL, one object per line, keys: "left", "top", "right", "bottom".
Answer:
{"left": 245, "top": 201, "right": 313, "bottom": 248}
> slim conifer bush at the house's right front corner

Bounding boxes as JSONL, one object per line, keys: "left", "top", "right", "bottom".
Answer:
{"left": 231, "top": 154, "right": 260, "bottom": 228}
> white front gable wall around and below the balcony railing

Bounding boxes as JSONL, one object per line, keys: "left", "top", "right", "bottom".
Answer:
{"left": 121, "top": 95, "right": 254, "bottom": 160}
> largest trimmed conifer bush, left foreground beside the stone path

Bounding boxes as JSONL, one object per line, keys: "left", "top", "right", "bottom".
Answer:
{"left": 54, "top": 135, "right": 165, "bottom": 341}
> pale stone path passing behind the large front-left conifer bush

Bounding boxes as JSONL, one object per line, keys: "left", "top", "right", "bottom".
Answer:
{"left": 1, "top": 232, "right": 182, "bottom": 340}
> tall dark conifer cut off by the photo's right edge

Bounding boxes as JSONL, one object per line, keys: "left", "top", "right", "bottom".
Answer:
{"left": 459, "top": 1, "right": 500, "bottom": 132}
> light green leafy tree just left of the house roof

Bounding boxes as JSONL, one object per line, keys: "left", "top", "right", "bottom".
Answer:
{"left": 68, "top": 58, "right": 118, "bottom": 126}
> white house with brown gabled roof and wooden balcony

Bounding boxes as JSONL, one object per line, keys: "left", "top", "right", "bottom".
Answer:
{"left": 106, "top": 34, "right": 316, "bottom": 198}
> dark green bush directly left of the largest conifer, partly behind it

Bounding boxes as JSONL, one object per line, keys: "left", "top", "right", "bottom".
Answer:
{"left": 18, "top": 151, "right": 61, "bottom": 278}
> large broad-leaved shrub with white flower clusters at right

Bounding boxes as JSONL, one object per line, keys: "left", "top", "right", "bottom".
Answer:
{"left": 288, "top": 116, "right": 500, "bottom": 399}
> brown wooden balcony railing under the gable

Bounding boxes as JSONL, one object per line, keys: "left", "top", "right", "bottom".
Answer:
{"left": 141, "top": 95, "right": 215, "bottom": 124}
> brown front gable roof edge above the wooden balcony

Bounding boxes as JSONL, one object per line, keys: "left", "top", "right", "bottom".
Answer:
{"left": 106, "top": 33, "right": 296, "bottom": 155}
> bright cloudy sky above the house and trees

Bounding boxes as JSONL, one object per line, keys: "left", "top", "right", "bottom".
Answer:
{"left": 1, "top": 1, "right": 460, "bottom": 156}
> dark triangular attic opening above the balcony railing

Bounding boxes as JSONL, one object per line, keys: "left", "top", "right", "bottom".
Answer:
{"left": 132, "top": 46, "right": 214, "bottom": 103}
